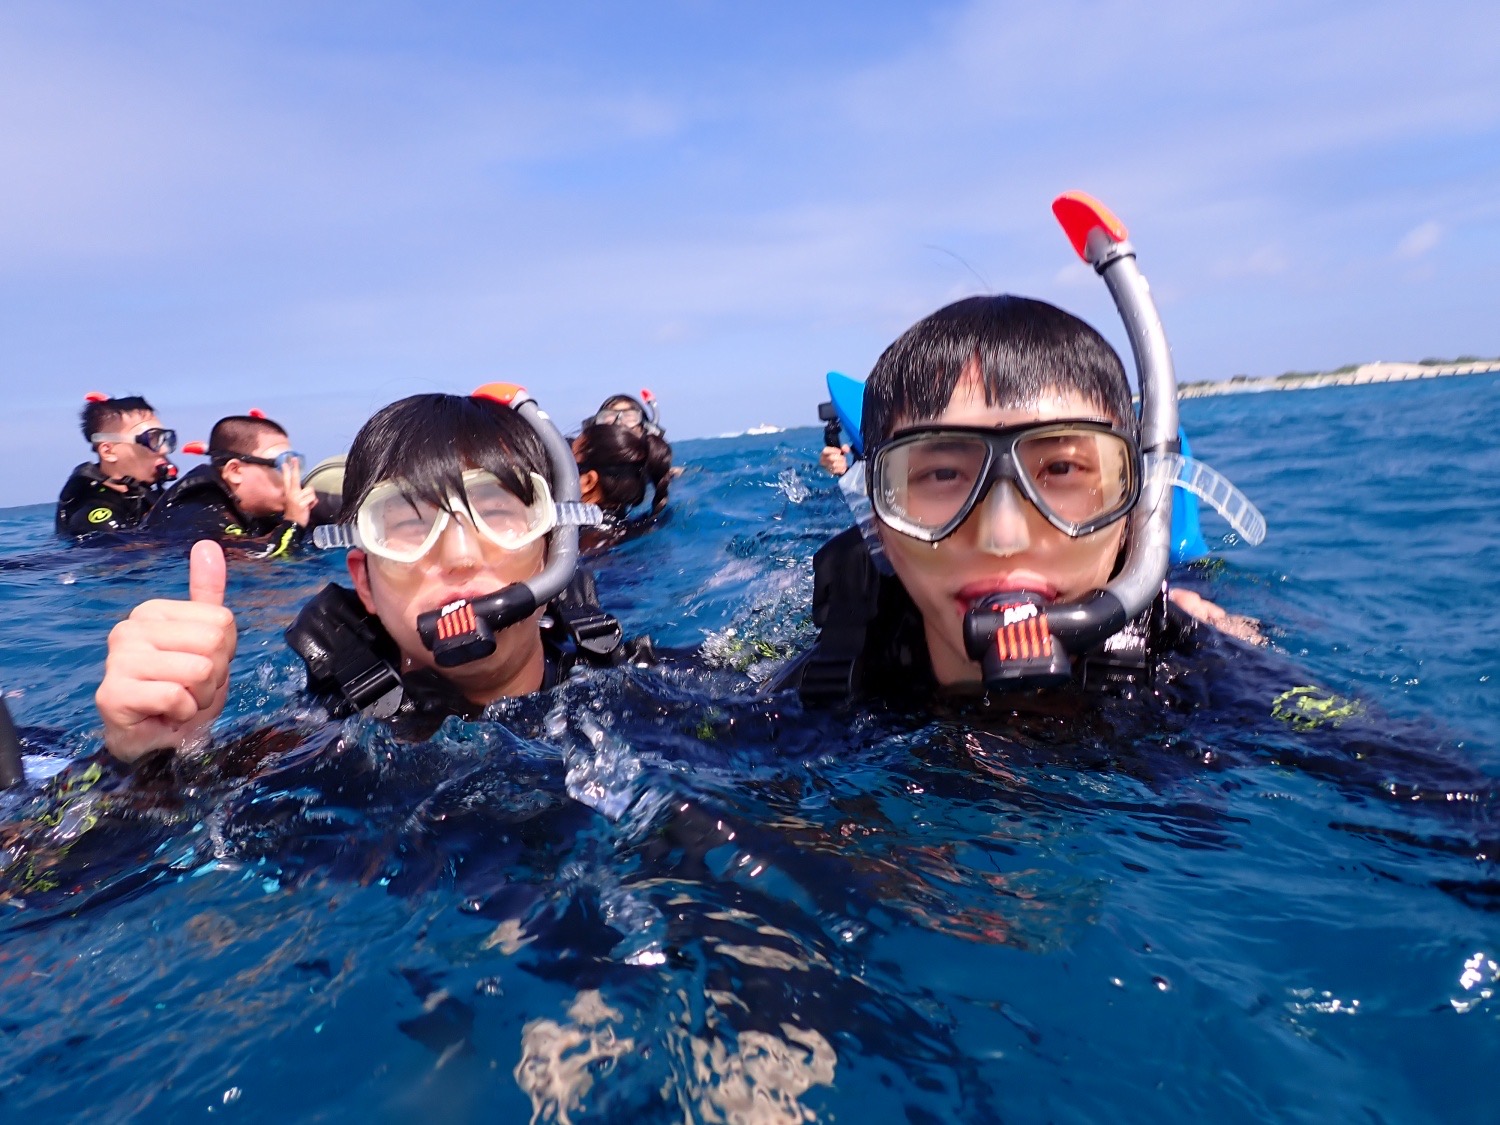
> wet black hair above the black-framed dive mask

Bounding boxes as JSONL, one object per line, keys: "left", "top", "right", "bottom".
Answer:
{"left": 861, "top": 296, "right": 1139, "bottom": 450}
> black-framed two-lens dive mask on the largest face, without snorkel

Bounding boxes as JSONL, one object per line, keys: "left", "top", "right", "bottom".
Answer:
{"left": 869, "top": 419, "right": 1142, "bottom": 543}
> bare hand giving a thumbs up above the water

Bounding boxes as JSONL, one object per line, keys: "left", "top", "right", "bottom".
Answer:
{"left": 95, "top": 540, "right": 237, "bottom": 762}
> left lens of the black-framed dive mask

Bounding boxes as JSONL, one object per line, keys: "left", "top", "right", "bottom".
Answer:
{"left": 875, "top": 434, "right": 989, "bottom": 533}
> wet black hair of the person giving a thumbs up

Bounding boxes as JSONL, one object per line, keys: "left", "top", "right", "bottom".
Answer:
{"left": 339, "top": 395, "right": 557, "bottom": 524}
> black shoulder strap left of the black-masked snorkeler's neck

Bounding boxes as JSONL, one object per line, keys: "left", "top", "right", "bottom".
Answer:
{"left": 797, "top": 528, "right": 881, "bottom": 707}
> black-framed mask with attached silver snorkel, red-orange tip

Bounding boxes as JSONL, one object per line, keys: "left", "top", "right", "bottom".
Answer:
{"left": 948, "top": 192, "right": 1266, "bottom": 690}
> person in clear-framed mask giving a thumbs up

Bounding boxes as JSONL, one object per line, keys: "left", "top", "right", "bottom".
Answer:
{"left": 96, "top": 384, "right": 647, "bottom": 762}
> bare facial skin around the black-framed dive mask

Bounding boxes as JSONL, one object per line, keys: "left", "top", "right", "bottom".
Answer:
{"left": 876, "top": 369, "right": 1127, "bottom": 686}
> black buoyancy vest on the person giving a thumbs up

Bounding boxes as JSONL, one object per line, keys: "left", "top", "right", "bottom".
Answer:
{"left": 285, "top": 570, "right": 656, "bottom": 719}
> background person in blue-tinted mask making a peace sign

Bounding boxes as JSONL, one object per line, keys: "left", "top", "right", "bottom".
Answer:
{"left": 144, "top": 411, "right": 318, "bottom": 558}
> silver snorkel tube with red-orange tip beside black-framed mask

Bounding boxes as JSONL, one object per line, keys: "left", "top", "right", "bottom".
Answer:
{"left": 963, "top": 192, "right": 1182, "bottom": 690}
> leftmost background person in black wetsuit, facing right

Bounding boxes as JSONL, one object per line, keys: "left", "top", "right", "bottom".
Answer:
{"left": 56, "top": 392, "right": 177, "bottom": 536}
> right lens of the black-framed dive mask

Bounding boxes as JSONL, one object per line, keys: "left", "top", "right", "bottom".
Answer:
{"left": 1016, "top": 428, "right": 1136, "bottom": 525}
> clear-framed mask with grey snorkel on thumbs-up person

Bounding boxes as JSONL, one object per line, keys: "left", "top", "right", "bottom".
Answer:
{"left": 312, "top": 383, "right": 605, "bottom": 668}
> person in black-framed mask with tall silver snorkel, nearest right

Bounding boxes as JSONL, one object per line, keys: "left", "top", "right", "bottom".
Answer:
{"left": 776, "top": 197, "right": 1263, "bottom": 702}
